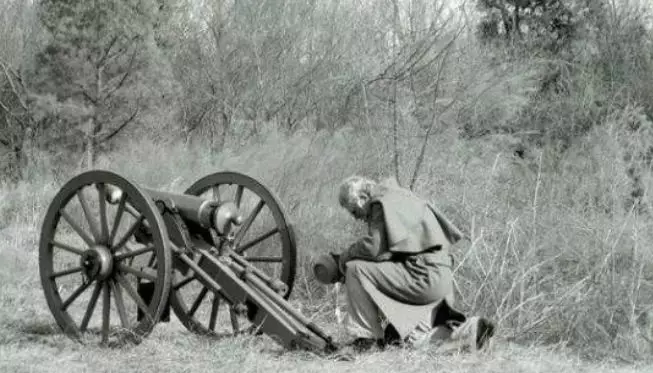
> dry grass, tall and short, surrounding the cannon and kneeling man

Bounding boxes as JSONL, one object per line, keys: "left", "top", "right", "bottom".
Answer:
{"left": 0, "top": 119, "right": 653, "bottom": 372}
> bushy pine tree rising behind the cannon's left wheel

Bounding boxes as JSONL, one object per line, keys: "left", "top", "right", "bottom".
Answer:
{"left": 32, "top": 0, "right": 174, "bottom": 168}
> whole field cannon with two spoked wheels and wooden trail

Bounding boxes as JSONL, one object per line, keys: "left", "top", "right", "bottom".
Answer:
{"left": 39, "top": 170, "right": 337, "bottom": 352}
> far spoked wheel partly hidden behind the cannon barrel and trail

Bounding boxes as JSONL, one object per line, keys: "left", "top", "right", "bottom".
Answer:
{"left": 170, "top": 172, "right": 297, "bottom": 335}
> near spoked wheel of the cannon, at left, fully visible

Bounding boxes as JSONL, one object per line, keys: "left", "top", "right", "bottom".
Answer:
{"left": 39, "top": 171, "right": 172, "bottom": 345}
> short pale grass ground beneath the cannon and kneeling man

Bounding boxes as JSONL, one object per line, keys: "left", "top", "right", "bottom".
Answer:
{"left": 0, "top": 316, "right": 653, "bottom": 373}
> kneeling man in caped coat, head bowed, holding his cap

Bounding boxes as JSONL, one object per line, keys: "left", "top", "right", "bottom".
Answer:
{"left": 313, "top": 176, "right": 494, "bottom": 352}
